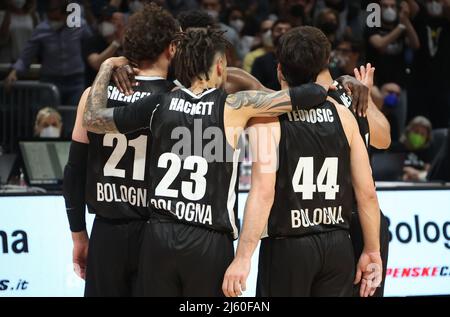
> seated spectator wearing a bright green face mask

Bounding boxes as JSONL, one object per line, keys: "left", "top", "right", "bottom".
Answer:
{"left": 392, "top": 116, "right": 433, "bottom": 181}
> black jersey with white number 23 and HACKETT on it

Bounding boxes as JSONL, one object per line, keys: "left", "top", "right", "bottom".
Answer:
{"left": 114, "top": 88, "right": 239, "bottom": 238}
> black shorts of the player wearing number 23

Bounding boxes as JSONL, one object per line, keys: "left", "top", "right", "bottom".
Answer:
{"left": 139, "top": 218, "right": 234, "bottom": 297}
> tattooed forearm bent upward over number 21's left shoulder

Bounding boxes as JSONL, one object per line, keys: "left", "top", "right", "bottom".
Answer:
{"left": 83, "top": 57, "right": 128, "bottom": 134}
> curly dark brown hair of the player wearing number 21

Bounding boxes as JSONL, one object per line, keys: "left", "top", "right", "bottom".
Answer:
{"left": 123, "top": 3, "right": 180, "bottom": 64}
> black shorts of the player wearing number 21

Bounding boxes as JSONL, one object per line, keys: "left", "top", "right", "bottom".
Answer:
{"left": 84, "top": 217, "right": 146, "bottom": 297}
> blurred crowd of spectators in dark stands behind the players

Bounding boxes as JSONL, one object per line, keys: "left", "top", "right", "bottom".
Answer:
{"left": 0, "top": 0, "right": 450, "bottom": 180}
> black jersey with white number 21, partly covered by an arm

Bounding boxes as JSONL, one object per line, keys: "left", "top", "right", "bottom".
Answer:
{"left": 86, "top": 76, "right": 174, "bottom": 219}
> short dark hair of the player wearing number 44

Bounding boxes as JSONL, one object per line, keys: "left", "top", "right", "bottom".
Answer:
{"left": 277, "top": 26, "right": 331, "bottom": 87}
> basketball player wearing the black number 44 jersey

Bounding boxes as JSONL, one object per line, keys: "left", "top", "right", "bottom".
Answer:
{"left": 223, "top": 27, "right": 381, "bottom": 297}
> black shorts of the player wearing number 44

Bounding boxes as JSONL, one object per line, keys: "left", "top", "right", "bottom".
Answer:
{"left": 256, "top": 230, "right": 355, "bottom": 297}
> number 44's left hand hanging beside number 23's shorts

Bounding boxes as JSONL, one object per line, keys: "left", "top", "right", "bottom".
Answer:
{"left": 222, "top": 258, "right": 251, "bottom": 297}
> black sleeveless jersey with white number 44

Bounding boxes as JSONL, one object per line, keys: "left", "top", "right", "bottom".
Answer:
{"left": 267, "top": 101, "right": 353, "bottom": 237}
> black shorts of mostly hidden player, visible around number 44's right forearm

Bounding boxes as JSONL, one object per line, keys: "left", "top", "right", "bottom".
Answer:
{"left": 350, "top": 211, "right": 389, "bottom": 297}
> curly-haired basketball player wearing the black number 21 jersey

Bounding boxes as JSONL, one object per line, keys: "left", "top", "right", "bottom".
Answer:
{"left": 64, "top": 4, "right": 179, "bottom": 296}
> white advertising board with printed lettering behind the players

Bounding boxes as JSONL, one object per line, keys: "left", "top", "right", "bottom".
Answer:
{"left": 0, "top": 190, "right": 450, "bottom": 296}
